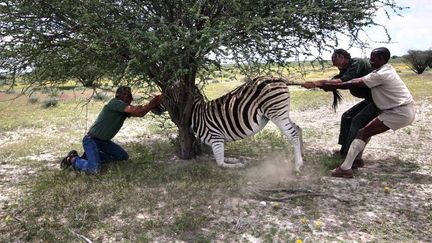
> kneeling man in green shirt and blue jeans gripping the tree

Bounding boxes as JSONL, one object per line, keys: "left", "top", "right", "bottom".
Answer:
{"left": 60, "top": 86, "right": 162, "bottom": 173}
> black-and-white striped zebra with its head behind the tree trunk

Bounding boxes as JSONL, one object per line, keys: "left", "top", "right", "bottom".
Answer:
{"left": 155, "top": 76, "right": 320, "bottom": 171}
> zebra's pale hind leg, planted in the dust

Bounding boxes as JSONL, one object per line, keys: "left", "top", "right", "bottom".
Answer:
{"left": 272, "top": 119, "right": 303, "bottom": 172}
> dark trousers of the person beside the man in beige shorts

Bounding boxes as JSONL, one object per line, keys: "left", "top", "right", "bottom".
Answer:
{"left": 338, "top": 100, "right": 381, "bottom": 154}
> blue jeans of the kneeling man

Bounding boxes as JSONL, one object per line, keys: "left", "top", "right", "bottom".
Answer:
{"left": 73, "top": 135, "right": 129, "bottom": 173}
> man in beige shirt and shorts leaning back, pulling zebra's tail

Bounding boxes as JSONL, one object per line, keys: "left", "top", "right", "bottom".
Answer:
{"left": 318, "top": 47, "right": 415, "bottom": 178}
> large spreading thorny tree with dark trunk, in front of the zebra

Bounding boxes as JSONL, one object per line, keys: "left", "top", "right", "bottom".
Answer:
{"left": 0, "top": 0, "right": 402, "bottom": 158}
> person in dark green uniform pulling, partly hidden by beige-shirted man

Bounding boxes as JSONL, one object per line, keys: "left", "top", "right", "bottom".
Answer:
{"left": 303, "top": 49, "right": 380, "bottom": 168}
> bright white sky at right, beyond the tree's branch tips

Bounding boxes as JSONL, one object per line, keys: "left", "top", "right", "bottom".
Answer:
{"left": 334, "top": 0, "right": 432, "bottom": 59}
